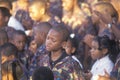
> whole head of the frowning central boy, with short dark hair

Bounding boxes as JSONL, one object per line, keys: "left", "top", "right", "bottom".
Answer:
{"left": 45, "top": 24, "right": 69, "bottom": 52}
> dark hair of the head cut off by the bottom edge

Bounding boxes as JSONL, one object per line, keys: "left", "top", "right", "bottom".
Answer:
{"left": 32, "top": 67, "right": 54, "bottom": 80}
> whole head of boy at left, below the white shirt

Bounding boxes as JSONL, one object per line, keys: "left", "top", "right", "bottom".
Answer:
{"left": 11, "top": 30, "right": 27, "bottom": 51}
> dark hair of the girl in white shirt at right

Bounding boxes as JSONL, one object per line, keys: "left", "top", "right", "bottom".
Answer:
{"left": 94, "top": 35, "right": 119, "bottom": 63}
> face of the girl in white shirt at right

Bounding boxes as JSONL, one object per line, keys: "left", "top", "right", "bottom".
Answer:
{"left": 91, "top": 41, "right": 103, "bottom": 60}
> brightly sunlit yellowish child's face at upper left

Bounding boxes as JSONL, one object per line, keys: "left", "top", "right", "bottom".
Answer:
{"left": 29, "top": 5, "right": 43, "bottom": 21}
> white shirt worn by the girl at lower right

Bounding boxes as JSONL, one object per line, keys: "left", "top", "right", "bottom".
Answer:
{"left": 91, "top": 55, "right": 114, "bottom": 80}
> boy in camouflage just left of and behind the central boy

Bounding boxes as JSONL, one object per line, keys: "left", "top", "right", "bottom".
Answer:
{"left": 30, "top": 22, "right": 52, "bottom": 76}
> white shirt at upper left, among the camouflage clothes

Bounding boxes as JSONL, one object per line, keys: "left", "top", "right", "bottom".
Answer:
{"left": 8, "top": 16, "right": 25, "bottom": 31}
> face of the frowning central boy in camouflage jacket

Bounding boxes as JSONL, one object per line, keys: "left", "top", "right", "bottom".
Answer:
{"left": 45, "top": 29, "right": 63, "bottom": 51}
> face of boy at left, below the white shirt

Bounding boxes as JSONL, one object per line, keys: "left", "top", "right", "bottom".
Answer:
{"left": 13, "top": 35, "right": 26, "bottom": 51}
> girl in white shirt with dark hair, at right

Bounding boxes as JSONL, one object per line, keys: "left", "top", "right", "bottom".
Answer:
{"left": 85, "top": 36, "right": 118, "bottom": 80}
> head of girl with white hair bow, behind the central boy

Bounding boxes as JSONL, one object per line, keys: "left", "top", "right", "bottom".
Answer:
{"left": 65, "top": 33, "right": 78, "bottom": 55}
